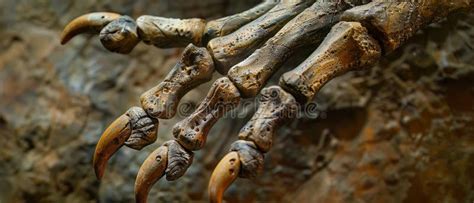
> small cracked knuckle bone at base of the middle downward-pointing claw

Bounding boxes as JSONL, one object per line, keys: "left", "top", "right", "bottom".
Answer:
{"left": 163, "top": 140, "right": 194, "bottom": 181}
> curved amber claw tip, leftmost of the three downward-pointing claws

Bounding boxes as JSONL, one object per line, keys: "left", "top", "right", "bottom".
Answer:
{"left": 93, "top": 114, "right": 132, "bottom": 180}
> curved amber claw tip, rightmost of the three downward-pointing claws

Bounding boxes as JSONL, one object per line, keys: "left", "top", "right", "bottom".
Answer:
{"left": 208, "top": 152, "right": 240, "bottom": 203}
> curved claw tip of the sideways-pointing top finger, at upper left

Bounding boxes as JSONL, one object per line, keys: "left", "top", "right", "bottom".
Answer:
{"left": 61, "top": 12, "right": 121, "bottom": 44}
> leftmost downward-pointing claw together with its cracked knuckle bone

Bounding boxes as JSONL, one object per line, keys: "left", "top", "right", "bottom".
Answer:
{"left": 93, "top": 107, "right": 158, "bottom": 179}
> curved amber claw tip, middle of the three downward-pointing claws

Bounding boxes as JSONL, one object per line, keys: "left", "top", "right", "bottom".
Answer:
{"left": 135, "top": 146, "right": 168, "bottom": 203}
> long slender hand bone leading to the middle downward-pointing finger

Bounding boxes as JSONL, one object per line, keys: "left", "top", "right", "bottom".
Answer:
{"left": 228, "top": 1, "right": 359, "bottom": 97}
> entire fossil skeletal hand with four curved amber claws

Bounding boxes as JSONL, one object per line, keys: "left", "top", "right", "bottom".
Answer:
{"left": 61, "top": 0, "right": 474, "bottom": 202}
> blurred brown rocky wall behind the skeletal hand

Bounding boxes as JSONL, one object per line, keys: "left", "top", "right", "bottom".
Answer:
{"left": 0, "top": 0, "right": 474, "bottom": 203}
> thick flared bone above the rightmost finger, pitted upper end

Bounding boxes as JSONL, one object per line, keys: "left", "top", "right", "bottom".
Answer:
{"left": 280, "top": 22, "right": 381, "bottom": 103}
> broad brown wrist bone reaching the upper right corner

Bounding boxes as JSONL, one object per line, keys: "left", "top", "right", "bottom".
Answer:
{"left": 342, "top": 0, "right": 474, "bottom": 52}
